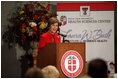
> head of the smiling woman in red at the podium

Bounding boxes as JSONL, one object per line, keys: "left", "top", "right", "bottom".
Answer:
{"left": 47, "top": 17, "right": 59, "bottom": 34}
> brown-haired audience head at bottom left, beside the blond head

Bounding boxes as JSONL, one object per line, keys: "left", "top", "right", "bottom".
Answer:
{"left": 25, "top": 67, "right": 44, "bottom": 78}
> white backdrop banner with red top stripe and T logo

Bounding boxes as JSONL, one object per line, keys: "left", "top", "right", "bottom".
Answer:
{"left": 57, "top": 2, "right": 114, "bottom": 61}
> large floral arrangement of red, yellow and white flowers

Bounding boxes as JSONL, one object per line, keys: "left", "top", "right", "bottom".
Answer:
{"left": 3, "top": 2, "right": 57, "bottom": 46}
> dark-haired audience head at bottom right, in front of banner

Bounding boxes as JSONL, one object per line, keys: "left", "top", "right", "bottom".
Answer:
{"left": 87, "top": 59, "right": 107, "bottom": 78}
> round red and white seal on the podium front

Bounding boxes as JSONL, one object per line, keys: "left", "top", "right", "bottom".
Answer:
{"left": 61, "top": 50, "right": 83, "bottom": 77}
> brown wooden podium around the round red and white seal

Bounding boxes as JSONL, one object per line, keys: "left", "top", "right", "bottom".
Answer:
{"left": 37, "top": 43, "right": 86, "bottom": 78}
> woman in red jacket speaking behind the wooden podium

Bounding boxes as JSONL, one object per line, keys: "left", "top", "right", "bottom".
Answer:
{"left": 38, "top": 17, "right": 61, "bottom": 53}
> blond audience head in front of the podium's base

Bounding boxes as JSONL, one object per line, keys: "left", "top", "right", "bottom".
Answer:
{"left": 42, "top": 65, "right": 59, "bottom": 78}
